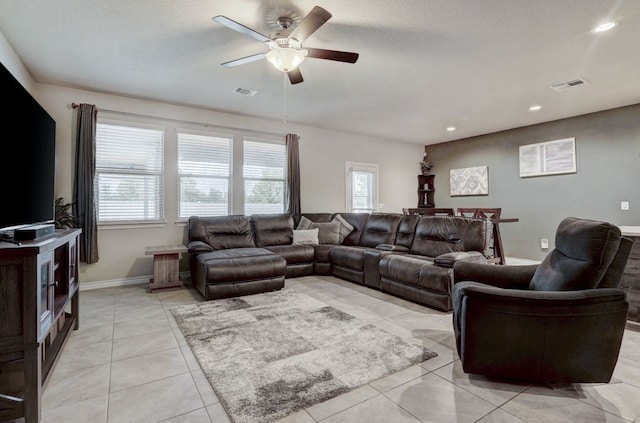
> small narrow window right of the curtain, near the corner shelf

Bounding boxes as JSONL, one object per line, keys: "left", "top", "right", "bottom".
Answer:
{"left": 346, "top": 162, "right": 378, "bottom": 213}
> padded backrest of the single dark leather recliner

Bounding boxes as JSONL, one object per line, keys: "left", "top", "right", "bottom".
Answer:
{"left": 529, "top": 217, "right": 621, "bottom": 291}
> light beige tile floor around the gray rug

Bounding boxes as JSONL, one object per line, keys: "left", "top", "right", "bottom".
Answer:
{"left": 8, "top": 277, "right": 640, "bottom": 423}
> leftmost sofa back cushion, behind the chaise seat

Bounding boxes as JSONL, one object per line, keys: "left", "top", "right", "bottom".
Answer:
{"left": 189, "top": 215, "right": 256, "bottom": 250}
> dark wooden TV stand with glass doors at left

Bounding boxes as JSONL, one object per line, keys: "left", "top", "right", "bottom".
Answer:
{"left": 0, "top": 229, "right": 81, "bottom": 423}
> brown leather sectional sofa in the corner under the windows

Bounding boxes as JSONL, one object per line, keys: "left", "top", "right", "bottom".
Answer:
{"left": 188, "top": 213, "right": 487, "bottom": 311}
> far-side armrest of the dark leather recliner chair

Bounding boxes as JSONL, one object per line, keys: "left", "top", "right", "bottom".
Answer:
{"left": 453, "top": 261, "right": 538, "bottom": 289}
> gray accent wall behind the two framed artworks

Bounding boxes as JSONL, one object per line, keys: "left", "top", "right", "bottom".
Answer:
{"left": 426, "top": 104, "right": 640, "bottom": 260}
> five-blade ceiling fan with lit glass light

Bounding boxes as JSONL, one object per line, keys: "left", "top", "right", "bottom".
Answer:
{"left": 213, "top": 6, "right": 358, "bottom": 84}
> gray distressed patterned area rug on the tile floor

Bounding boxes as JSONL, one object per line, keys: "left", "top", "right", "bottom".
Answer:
{"left": 171, "top": 288, "right": 436, "bottom": 423}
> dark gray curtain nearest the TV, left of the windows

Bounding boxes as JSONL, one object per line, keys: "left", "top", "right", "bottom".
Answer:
{"left": 73, "top": 104, "right": 99, "bottom": 264}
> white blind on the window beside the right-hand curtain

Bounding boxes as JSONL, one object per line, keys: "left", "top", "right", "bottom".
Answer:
{"left": 243, "top": 139, "right": 287, "bottom": 215}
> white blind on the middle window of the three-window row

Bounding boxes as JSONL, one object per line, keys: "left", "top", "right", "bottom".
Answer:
{"left": 178, "top": 131, "right": 233, "bottom": 220}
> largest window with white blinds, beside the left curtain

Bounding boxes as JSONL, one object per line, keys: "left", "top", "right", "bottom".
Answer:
{"left": 95, "top": 120, "right": 164, "bottom": 224}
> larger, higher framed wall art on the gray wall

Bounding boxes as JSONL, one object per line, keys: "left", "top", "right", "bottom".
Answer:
{"left": 520, "top": 138, "right": 576, "bottom": 178}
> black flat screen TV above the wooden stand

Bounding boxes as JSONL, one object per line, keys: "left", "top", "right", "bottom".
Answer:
{"left": 0, "top": 63, "right": 56, "bottom": 234}
